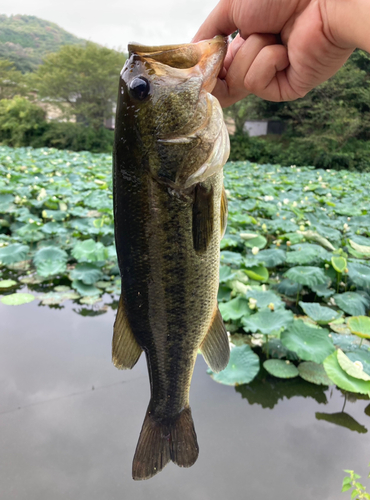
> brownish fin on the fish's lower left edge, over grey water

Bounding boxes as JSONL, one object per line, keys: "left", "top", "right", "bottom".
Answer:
{"left": 112, "top": 297, "right": 142, "bottom": 370}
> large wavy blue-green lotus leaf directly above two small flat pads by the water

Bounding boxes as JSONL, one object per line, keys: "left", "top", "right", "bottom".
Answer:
{"left": 280, "top": 320, "right": 335, "bottom": 363}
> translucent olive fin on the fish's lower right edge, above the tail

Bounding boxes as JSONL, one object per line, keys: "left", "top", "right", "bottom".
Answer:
{"left": 200, "top": 307, "right": 230, "bottom": 373}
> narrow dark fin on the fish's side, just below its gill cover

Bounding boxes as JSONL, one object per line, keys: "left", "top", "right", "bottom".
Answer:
{"left": 193, "top": 184, "right": 213, "bottom": 252}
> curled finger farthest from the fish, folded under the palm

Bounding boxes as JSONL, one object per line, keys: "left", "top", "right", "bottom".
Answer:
{"left": 244, "top": 45, "right": 301, "bottom": 102}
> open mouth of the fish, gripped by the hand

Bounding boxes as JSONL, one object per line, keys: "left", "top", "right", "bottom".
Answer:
{"left": 128, "top": 35, "right": 227, "bottom": 92}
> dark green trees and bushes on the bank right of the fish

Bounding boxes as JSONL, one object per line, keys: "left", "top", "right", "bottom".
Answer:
{"left": 226, "top": 50, "right": 370, "bottom": 172}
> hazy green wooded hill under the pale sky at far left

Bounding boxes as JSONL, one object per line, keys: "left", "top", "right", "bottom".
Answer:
{"left": 0, "top": 15, "right": 85, "bottom": 73}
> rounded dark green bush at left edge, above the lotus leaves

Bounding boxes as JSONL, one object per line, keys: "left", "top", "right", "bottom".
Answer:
{"left": 0, "top": 96, "right": 47, "bottom": 147}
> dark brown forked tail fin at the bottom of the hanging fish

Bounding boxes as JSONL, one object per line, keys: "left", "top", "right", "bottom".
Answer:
{"left": 132, "top": 406, "right": 199, "bottom": 480}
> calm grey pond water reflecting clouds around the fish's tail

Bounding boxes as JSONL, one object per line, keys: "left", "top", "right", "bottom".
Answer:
{"left": 0, "top": 303, "right": 370, "bottom": 500}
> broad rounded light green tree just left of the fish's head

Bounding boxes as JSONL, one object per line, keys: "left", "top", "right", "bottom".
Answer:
{"left": 33, "top": 42, "right": 125, "bottom": 129}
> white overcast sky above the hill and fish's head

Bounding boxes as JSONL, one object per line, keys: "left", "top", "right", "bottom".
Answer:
{"left": 0, "top": 0, "right": 217, "bottom": 50}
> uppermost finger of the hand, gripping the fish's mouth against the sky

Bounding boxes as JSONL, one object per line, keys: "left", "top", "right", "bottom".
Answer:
{"left": 192, "top": 0, "right": 236, "bottom": 43}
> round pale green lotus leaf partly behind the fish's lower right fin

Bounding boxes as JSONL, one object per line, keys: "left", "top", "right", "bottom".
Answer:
{"left": 208, "top": 344, "right": 260, "bottom": 385}
